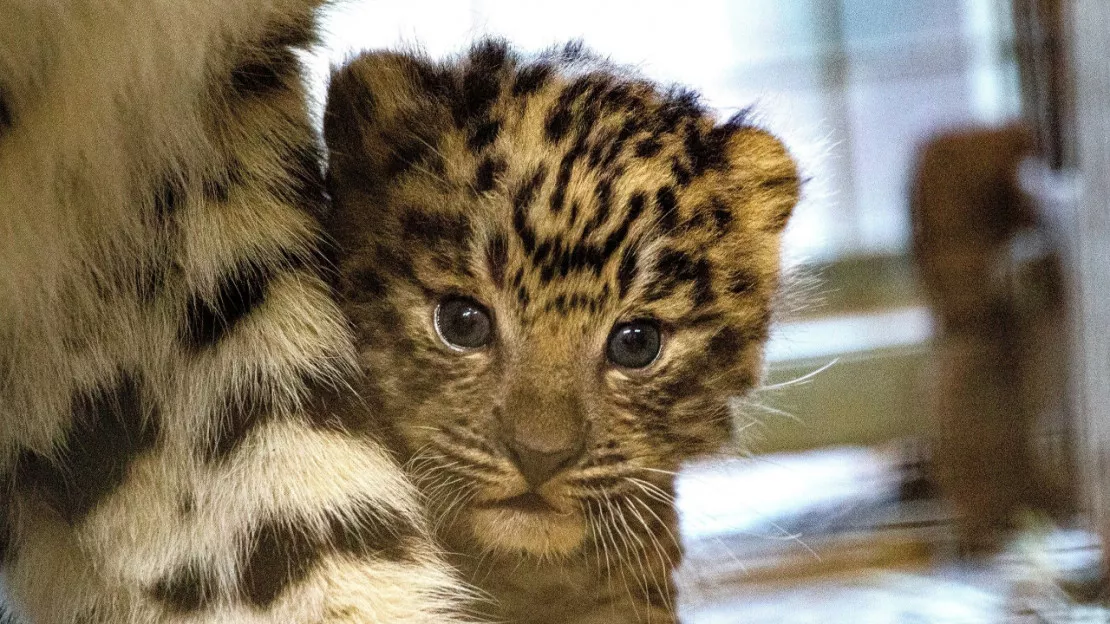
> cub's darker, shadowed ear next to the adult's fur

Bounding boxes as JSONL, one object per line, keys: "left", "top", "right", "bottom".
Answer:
{"left": 324, "top": 52, "right": 452, "bottom": 191}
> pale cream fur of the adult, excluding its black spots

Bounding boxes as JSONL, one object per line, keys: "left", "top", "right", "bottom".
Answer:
{"left": 0, "top": 0, "right": 467, "bottom": 624}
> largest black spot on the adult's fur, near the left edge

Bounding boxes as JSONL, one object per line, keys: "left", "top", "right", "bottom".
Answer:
{"left": 16, "top": 374, "right": 159, "bottom": 525}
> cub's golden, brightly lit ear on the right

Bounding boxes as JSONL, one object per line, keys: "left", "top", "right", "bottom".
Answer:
{"left": 710, "top": 113, "right": 801, "bottom": 234}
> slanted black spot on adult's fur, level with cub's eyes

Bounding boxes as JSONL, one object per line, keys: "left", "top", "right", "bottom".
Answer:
{"left": 181, "top": 256, "right": 271, "bottom": 350}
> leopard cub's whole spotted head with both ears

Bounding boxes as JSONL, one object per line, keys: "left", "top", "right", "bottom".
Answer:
{"left": 324, "top": 41, "right": 799, "bottom": 555}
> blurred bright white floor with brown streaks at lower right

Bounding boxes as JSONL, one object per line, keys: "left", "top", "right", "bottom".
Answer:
{"left": 679, "top": 449, "right": 1110, "bottom": 624}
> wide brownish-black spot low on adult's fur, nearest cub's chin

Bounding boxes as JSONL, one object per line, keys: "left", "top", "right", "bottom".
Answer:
{"left": 239, "top": 503, "right": 421, "bottom": 608}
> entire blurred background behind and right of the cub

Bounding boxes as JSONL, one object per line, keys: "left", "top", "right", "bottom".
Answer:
{"left": 312, "top": 0, "right": 1110, "bottom": 624}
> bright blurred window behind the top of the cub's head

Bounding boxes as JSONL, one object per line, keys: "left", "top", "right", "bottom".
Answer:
{"left": 315, "top": 0, "right": 1019, "bottom": 260}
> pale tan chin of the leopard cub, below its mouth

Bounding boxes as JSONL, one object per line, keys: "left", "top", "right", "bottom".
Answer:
{"left": 467, "top": 504, "right": 586, "bottom": 557}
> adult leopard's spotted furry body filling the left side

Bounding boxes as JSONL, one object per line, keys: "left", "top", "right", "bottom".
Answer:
{"left": 0, "top": 0, "right": 465, "bottom": 624}
